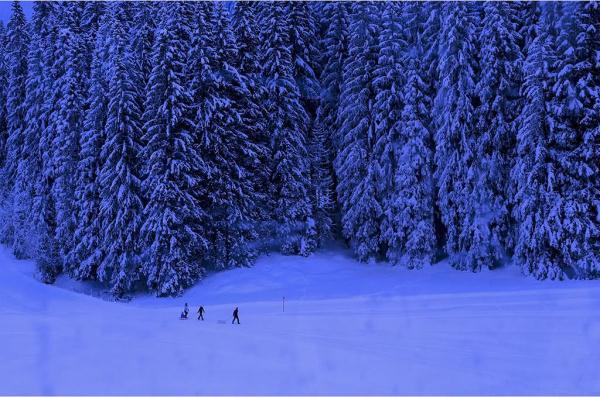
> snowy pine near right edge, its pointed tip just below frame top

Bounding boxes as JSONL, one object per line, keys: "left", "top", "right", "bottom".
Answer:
{"left": 511, "top": 17, "right": 564, "bottom": 279}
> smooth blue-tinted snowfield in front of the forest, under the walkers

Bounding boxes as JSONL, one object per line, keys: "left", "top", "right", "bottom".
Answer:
{"left": 0, "top": 244, "right": 600, "bottom": 394}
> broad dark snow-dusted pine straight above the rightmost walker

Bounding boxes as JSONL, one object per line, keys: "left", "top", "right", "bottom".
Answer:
{"left": 195, "top": 4, "right": 260, "bottom": 269}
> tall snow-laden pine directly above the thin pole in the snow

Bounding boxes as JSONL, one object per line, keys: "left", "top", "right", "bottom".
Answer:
{"left": 261, "top": 3, "right": 310, "bottom": 254}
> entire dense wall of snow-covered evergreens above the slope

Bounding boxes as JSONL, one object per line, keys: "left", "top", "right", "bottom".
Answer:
{"left": 0, "top": 2, "right": 600, "bottom": 296}
